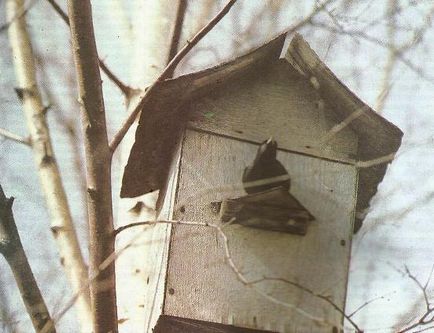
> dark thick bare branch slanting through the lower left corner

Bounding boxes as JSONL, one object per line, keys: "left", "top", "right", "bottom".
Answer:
{"left": 0, "top": 185, "right": 56, "bottom": 333}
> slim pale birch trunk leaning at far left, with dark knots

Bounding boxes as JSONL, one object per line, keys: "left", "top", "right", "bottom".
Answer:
{"left": 6, "top": 0, "right": 92, "bottom": 333}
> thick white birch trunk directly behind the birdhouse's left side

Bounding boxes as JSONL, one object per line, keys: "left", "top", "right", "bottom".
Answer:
{"left": 116, "top": 0, "right": 216, "bottom": 333}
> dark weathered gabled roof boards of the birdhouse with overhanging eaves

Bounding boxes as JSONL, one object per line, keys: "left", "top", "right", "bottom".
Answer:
{"left": 121, "top": 33, "right": 402, "bottom": 224}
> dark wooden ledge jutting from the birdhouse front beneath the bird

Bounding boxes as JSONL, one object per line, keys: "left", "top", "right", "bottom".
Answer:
{"left": 212, "top": 186, "right": 315, "bottom": 235}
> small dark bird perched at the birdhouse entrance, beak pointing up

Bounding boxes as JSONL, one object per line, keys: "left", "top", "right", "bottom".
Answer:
{"left": 242, "top": 138, "right": 291, "bottom": 194}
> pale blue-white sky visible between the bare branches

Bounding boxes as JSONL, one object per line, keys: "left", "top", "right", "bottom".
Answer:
{"left": 0, "top": 0, "right": 434, "bottom": 332}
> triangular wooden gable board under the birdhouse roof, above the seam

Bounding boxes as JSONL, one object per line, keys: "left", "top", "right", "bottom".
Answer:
{"left": 189, "top": 60, "right": 358, "bottom": 162}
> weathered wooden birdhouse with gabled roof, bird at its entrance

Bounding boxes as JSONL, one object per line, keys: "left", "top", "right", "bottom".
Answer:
{"left": 121, "top": 34, "right": 402, "bottom": 332}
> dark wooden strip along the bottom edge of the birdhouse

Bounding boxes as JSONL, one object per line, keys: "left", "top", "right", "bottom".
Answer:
{"left": 154, "top": 316, "right": 274, "bottom": 333}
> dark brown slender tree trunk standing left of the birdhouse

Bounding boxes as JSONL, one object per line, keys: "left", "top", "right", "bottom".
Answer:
{"left": 68, "top": 0, "right": 118, "bottom": 333}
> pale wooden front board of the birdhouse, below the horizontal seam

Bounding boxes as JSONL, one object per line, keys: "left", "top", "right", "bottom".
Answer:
{"left": 163, "top": 130, "right": 357, "bottom": 332}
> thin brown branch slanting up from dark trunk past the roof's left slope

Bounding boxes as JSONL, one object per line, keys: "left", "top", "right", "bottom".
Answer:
{"left": 107, "top": 0, "right": 237, "bottom": 152}
